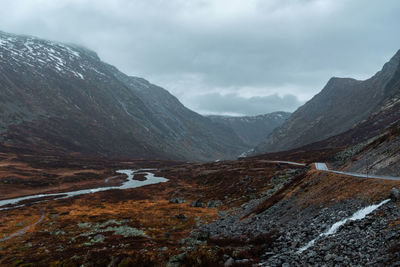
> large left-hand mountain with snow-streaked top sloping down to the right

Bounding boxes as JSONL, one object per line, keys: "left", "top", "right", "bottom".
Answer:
{"left": 0, "top": 32, "right": 247, "bottom": 160}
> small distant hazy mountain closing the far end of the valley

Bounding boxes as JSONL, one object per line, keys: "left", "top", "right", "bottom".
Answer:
{"left": 208, "top": 112, "right": 290, "bottom": 148}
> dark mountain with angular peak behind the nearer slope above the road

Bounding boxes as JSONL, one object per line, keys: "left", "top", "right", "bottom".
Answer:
{"left": 255, "top": 51, "right": 400, "bottom": 154}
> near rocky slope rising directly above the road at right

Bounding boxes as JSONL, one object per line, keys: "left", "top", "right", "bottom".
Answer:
{"left": 290, "top": 61, "right": 400, "bottom": 176}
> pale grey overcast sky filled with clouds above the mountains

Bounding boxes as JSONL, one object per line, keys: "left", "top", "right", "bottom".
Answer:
{"left": 0, "top": 0, "right": 400, "bottom": 115}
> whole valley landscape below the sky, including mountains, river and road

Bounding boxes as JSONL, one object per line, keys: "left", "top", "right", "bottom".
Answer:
{"left": 0, "top": 31, "right": 400, "bottom": 267}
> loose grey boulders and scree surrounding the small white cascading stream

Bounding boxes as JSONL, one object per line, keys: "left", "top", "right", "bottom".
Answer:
{"left": 195, "top": 184, "right": 400, "bottom": 266}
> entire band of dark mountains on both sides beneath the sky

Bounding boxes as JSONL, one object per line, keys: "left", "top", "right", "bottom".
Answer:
{"left": 0, "top": 32, "right": 400, "bottom": 165}
